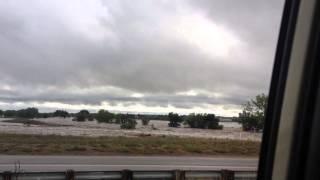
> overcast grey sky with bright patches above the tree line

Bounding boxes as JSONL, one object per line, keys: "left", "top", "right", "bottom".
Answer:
{"left": 0, "top": 0, "right": 283, "bottom": 116}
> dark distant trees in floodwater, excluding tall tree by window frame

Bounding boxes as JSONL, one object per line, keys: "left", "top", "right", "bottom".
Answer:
{"left": 0, "top": 107, "right": 222, "bottom": 129}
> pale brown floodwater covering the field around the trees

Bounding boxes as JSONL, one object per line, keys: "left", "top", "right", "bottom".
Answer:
{"left": 0, "top": 118, "right": 262, "bottom": 141}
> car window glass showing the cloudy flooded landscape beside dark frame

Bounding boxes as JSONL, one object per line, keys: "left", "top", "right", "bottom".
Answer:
{"left": 0, "top": 0, "right": 284, "bottom": 179}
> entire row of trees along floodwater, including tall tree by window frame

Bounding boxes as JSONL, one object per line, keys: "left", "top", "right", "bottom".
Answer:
{"left": 0, "top": 94, "right": 268, "bottom": 131}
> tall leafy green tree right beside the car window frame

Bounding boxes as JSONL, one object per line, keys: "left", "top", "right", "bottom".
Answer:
{"left": 239, "top": 94, "right": 268, "bottom": 131}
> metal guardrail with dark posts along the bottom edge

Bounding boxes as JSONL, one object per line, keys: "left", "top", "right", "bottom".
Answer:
{"left": 0, "top": 170, "right": 256, "bottom": 180}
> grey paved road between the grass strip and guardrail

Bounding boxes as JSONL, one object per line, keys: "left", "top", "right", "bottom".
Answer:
{"left": 0, "top": 155, "right": 258, "bottom": 172}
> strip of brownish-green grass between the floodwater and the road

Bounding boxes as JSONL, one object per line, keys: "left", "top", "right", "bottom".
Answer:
{"left": 0, "top": 134, "right": 260, "bottom": 156}
